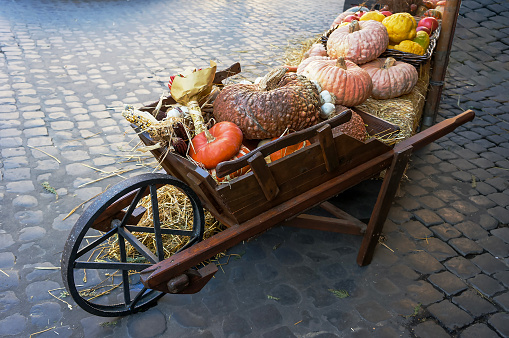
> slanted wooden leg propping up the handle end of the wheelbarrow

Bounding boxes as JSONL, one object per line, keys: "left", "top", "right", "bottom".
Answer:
{"left": 357, "top": 146, "right": 412, "bottom": 266}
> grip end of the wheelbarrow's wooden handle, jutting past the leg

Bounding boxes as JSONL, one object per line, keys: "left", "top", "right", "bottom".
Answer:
{"left": 394, "top": 110, "right": 475, "bottom": 151}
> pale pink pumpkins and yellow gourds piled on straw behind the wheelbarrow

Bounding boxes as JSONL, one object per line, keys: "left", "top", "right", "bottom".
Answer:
{"left": 296, "top": 7, "right": 438, "bottom": 106}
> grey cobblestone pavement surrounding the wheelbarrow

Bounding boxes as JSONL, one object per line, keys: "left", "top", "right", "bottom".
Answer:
{"left": 0, "top": 0, "right": 509, "bottom": 338}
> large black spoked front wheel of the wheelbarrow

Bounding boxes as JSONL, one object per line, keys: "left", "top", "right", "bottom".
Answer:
{"left": 61, "top": 174, "right": 205, "bottom": 317}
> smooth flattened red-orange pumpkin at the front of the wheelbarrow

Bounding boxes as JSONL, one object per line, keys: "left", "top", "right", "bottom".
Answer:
{"left": 189, "top": 121, "right": 242, "bottom": 169}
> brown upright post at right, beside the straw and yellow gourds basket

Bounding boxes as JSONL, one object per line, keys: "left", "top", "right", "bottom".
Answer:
{"left": 421, "top": 0, "right": 461, "bottom": 129}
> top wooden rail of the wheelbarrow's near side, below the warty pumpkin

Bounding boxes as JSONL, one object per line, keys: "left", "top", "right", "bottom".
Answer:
{"left": 212, "top": 109, "right": 352, "bottom": 177}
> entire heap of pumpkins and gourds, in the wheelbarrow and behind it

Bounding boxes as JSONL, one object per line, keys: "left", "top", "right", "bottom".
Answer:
{"left": 124, "top": 6, "right": 440, "bottom": 182}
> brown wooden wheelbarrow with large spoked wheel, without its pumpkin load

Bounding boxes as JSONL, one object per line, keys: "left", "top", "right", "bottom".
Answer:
{"left": 62, "top": 62, "right": 474, "bottom": 316}
